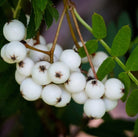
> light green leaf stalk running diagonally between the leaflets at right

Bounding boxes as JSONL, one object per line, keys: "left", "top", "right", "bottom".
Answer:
{"left": 73, "top": 8, "right": 138, "bottom": 85}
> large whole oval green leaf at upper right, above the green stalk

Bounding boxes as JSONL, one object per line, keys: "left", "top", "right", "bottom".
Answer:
{"left": 111, "top": 25, "right": 131, "bottom": 56}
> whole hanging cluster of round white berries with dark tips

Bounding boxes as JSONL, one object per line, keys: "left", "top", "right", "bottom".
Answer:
{"left": 1, "top": 20, "right": 124, "bottom": 118}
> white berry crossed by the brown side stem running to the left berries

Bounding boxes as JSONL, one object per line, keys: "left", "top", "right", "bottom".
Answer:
{"left": 29, "top": 44, "right": 49, "bottom": 62}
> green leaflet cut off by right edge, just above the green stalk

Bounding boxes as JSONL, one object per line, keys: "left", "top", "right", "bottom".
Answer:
{"left": 126, "top": 45, "right": 138, "bottom": 71}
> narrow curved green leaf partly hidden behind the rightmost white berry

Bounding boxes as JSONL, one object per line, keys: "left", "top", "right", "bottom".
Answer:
{"left": 118, "top": 72, "right": 131, "bottom": 102}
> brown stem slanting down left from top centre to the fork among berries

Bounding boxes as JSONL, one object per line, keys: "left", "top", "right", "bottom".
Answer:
{"left": 50, "top": 2, "right": 67, "bottom": 63}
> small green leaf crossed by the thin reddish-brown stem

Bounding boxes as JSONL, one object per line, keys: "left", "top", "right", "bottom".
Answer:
{"left": 78, "top": 40, "right": 98, "bottom": 57}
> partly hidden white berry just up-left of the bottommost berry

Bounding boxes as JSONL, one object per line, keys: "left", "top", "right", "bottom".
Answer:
{"left": 72, "top": 91, "right": 88, "bottom": 104}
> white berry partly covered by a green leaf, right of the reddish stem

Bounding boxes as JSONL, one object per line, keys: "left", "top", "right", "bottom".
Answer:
{"left": 92, "top": 51, "right": 108, "bottom": 68}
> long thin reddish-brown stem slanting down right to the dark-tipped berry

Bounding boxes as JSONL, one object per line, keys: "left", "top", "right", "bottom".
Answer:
{"left": 70, "top": 1, "right": 98, "bottom": 79}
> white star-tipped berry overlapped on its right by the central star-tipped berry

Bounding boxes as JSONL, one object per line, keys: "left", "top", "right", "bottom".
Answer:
{"left": 32, "top": 61, "right": 51, "bottom": 85}
